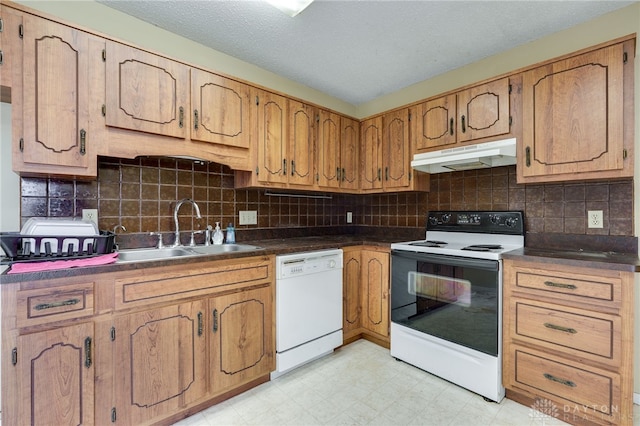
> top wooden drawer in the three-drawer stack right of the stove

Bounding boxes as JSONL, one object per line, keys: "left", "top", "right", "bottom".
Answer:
{"left": 514, "top": 268, "right": 622, "bottom": 303}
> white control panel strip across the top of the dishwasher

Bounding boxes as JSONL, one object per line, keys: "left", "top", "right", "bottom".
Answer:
{"left": 276, "top": 249, "right": 342, "bottom": 279}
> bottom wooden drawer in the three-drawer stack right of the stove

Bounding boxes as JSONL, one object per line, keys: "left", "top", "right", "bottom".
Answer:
{"left": 513, "top": 348, "right": 620, "bottom": 422}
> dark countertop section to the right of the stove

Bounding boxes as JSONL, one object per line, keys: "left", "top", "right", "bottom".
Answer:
{"left": 502, "top": 247, "right": 640, "bottom": 272}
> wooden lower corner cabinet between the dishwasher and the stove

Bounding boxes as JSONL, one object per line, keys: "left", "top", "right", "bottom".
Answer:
{"left": 342, "top": 246, "right": 390, "bottom": 347}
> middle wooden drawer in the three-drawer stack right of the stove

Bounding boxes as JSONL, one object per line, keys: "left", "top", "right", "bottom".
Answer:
{"left": 512, "top": 299, "right": 620, "bottom": 360}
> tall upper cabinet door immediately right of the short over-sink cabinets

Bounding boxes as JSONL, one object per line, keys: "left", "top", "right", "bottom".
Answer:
{"left": 256, "top": 92, "right": 287, "bottom": 183}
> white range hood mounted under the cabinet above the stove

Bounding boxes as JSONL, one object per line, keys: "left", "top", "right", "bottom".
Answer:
{"left": 411, "top": 138, "right": 516, "bottom": 173}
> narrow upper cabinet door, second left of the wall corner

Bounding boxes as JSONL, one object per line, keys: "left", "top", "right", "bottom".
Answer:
{"left": 317, "top": 110, "right": 342, "bottom": 188}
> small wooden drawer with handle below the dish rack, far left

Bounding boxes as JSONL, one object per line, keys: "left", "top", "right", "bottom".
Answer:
{"left": 16, "top": 282, "right": 94, "bottom": 327}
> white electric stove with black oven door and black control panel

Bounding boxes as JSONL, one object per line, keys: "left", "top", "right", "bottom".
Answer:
{"left": 391, "top": 212, "right": 524, "bottom": 402}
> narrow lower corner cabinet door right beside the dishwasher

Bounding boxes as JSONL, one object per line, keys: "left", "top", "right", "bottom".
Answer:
{"left": 342, "top": 247, "right": 362, "bottom": 341}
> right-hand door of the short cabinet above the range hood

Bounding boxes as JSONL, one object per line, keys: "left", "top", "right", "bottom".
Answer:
{"left": 457, "top": 78, "right": 509, "bottom": 142}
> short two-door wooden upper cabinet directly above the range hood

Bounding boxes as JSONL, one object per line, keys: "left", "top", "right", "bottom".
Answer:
{"left": 411, "top": 78, "right": 511, "bottom": 151}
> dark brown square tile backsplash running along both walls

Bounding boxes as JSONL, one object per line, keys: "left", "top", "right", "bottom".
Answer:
{"left": 21, "top": 157, "right": 633, "bottom": 240}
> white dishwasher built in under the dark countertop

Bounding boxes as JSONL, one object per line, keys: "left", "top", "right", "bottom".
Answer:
{"left": 271, "top": 249, "right": 342, "bottom": 378}
